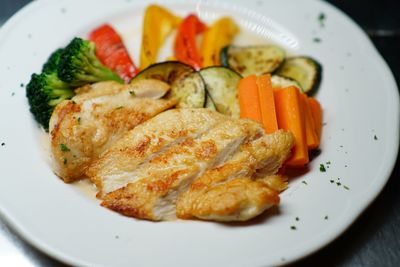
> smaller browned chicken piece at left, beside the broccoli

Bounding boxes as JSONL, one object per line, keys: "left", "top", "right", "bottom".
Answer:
{"left": 50, "top": 82, "right": 176, "bottom": 182}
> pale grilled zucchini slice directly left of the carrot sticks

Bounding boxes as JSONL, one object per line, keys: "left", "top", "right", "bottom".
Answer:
{"left": 200, "top": 67, "right": 242, "bottom": 118}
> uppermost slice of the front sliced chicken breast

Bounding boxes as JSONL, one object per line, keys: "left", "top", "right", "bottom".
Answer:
{"left": 86, "top": 109, "right": 234, "bottom": 197}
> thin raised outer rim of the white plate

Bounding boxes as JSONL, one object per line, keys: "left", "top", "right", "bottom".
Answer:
{"left": 0, "top": 0, "right": 400, "bottom": 266}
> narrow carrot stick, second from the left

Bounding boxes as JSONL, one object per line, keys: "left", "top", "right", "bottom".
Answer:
{"left": 257, "top": 74, "right": 278, "bottom": 133}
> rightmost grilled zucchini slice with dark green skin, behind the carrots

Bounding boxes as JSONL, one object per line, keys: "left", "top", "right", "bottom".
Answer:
{"left": 276, "top": 56, "right": 322, "bottom": 95}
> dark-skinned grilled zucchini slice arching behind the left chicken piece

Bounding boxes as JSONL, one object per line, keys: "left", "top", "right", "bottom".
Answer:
{"left": 130, "top": 61, "right": 206, "bottom": 108}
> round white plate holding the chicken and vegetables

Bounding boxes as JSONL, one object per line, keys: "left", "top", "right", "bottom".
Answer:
{"left": 0, "top": 0, "right": 399, "bottom": 266}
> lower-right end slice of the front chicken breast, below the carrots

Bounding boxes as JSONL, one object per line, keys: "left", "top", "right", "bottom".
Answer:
{"left": 176, "top": 131, "right": 294, "bottom": 221}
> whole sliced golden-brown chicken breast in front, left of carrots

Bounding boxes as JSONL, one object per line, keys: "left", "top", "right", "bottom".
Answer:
{"left": 87, "top": 109, "right": 293, "bottom": 221}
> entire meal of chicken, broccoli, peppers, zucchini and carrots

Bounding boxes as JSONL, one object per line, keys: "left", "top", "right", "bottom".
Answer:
{"left": 26, "top": 5, "right": 322, "bottom": 221}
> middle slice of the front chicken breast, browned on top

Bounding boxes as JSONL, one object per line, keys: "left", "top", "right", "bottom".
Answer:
{"left": 102, "top": 118, "right": 263, "bottom": 220}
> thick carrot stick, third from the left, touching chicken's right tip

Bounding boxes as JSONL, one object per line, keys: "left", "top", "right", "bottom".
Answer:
{"left": 274, "top": 86, "right": 309, "bottom": 167}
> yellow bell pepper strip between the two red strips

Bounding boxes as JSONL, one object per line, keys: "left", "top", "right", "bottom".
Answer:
{"left": 140, "top": 5, "right": 181, "bottom": 69}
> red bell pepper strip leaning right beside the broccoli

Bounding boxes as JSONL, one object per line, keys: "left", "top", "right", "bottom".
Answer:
{"left": 89, "top": 24, "right": 139, "bottom": 83}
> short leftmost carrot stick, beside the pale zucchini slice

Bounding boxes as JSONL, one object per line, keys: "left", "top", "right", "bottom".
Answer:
{"left": 238, "top": 75, "right": 262, "bottom": 123}
